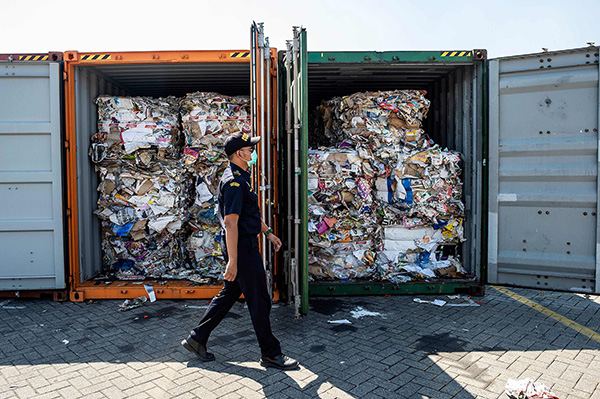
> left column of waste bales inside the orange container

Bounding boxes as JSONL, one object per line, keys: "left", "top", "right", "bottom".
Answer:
{"left": 90, "top": 96, "right": 187, "bottom": 279}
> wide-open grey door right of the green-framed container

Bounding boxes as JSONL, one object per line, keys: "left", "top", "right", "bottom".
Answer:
{"left": 488, "top": 46, "right": 600, "bottom": 293}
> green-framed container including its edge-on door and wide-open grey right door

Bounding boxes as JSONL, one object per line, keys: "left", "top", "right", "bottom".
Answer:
{"left": 278, "top": 28, "right": 600, "bottom": 315}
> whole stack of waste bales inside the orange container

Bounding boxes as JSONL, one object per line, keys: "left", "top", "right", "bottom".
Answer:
{"left": 90, "top": 92, "right": 250, "bottom": 283}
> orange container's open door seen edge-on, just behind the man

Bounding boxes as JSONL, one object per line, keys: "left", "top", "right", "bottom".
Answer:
{"left": 250, "top": 22, "right": 279, "bottom": 298}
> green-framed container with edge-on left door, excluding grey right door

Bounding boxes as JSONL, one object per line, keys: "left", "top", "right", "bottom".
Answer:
{"left": 278, "top": 29, "right": 487, "bottom": 316}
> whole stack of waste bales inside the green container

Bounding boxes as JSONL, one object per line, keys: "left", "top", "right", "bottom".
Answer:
{"left": 308, "top": 90, "right": 466, "bottom": 283}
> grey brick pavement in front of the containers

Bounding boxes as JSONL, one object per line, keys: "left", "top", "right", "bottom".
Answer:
{"left": 0, "top": 287, "right": 600, "bottom": 399}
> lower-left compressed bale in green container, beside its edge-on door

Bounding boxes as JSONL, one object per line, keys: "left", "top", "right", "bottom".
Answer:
{"left": 308, "top": 150, "right": 379, "bottom": 279}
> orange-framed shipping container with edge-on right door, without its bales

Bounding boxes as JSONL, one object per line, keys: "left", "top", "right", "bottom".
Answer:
{"left": 65, "top": 36, "right": 278, "bottom": 301}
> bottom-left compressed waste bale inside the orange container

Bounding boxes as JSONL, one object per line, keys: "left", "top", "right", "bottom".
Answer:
{"left": 95, "top": 161, "right": 188, "bottom": 278}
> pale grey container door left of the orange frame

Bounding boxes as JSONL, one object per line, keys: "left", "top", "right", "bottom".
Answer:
{"left": 0, "top": 53, "right": 65, "bottom": 291}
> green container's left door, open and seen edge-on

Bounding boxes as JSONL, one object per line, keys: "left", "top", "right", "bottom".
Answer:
{"left": 280, "top": 27, "right": 308, "bottom": 317}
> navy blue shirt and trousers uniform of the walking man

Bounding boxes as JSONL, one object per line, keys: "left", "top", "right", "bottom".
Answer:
{"left": 191, "top": 164, "right": 281, "bottom": 357}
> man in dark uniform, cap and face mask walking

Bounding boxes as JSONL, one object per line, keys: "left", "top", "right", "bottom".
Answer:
{"left": 181, "top": 133, "right": 298, "bottom": 370}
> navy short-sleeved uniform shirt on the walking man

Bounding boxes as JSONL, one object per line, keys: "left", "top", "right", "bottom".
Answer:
{"left": 218, "top": 163, "right": 262, "bottom": 236}
